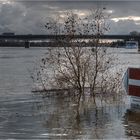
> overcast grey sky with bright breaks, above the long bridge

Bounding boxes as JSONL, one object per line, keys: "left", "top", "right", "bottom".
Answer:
{"left": 0, "top": 0, "right": 140, "bottom": 34}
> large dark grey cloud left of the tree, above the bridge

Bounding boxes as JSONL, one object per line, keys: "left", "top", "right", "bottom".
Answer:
{"left": 0, "top": 3, "right": 49, "bottom": 34}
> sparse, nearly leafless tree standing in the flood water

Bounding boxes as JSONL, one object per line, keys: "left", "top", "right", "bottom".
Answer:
{"left": 34, "top": 9, "right": 121, "bottom": 105}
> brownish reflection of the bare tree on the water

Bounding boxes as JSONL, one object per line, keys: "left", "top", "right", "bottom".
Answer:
{"left": 33, "top": 96, "right": 125, "bottom": 139}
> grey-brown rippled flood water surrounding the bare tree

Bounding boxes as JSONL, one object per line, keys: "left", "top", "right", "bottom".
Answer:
{"left": 0, "top": 48, "right": 140, "bottom": 139}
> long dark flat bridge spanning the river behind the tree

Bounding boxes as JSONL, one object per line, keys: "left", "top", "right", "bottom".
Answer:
{"left": 0, "top": 35, "right": 140, "bottom": 49}
